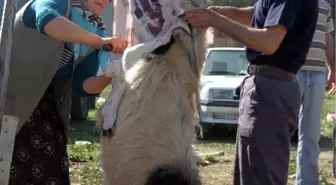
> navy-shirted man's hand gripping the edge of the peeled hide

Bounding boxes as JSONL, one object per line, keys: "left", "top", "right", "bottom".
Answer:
{"left": 185, "top": 8, "right": 220, "bottom": 28}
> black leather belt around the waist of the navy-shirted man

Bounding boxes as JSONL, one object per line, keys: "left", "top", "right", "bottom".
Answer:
{"left": 247, "top": 64, "right": 294, "bottom": 81}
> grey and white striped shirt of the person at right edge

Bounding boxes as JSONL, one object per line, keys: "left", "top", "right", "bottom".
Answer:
{"left": 301, "top": 0, "right": 334, "bottom": 71}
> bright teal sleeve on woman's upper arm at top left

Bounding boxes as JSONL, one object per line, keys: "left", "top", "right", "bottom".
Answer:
{"left": 23, "top": 0, "right": 68, "bottom": 33}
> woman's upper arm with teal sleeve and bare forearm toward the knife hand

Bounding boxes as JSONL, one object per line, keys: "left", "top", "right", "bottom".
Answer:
{"left": 24, "top": 0, "right": 104, "bottom": 48}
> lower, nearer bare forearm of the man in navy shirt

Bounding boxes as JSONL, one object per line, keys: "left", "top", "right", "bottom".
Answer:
{"left": 214, "top": 15, "right": 287, "bottom": 55}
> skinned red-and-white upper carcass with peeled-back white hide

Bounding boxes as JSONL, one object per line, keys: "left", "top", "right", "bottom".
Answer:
{"left": 101, "top": 0, "right": 204, "bottom": 130}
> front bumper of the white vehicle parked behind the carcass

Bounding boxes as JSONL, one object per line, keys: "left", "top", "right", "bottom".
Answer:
{"left": 199, "top": 101, "right": 239, "bottom": 125}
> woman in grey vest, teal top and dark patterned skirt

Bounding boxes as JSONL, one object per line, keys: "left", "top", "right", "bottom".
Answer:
{"left": 4, "top": 0, "right": 126, "bottom": 185}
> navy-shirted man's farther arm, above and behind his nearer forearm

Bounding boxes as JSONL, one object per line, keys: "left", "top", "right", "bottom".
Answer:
{"left": 209, "top": 6, "right": 254, "bottom": 26}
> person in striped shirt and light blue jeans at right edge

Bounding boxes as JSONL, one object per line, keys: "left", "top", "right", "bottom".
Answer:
{"left": 296, "top": 0, "right": 336, "bottom": 185}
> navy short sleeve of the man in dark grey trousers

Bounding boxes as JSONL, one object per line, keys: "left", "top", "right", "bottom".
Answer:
{"left": 265, "top": 0, "right": 302, "bottom": 30}
